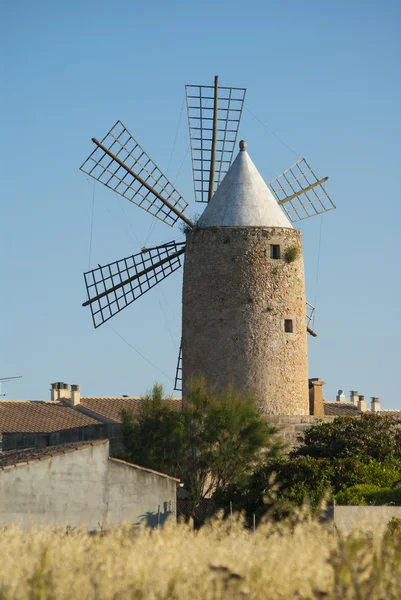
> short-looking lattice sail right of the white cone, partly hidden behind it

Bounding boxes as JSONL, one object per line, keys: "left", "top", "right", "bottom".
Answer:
{"left": 269, "top": 158, "right": 335, "bottom": 223}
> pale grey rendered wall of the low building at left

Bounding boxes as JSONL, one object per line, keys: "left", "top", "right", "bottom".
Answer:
{"left": 0, "top": 441, "right": 177, "bottom": 529}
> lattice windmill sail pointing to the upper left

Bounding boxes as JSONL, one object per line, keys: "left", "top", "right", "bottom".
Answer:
{"left": 80, "top": 121, "right": 192, "bottom": 226}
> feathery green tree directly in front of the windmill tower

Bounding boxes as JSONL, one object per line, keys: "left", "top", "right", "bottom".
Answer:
{"left": 122, "top": 380, "right": 280, "bottom": 507}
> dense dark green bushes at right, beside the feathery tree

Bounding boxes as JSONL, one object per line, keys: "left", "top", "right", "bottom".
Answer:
{"left": 219, "top": 413, "right": 401, "bottom": 520}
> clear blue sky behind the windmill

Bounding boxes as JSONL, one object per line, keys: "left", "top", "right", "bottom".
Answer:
{"left": 0, "top": 0, "right": 401, "bottom": 408}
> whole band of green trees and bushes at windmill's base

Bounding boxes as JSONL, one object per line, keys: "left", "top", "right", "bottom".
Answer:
{"left": 123, "top": 390, "right": 401, "bottom": 524}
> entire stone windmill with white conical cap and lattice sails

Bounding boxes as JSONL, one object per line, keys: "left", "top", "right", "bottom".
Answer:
{"left": 80, "top": 77, "right": 335, "bottom": 414}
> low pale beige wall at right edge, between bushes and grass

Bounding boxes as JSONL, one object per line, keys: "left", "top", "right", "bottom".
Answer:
{"left": 333, "top": 505, "right": 401, "bottom": 533}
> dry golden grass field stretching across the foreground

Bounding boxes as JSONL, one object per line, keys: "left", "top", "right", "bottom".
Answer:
{"left": 0, "top": 510, "right": 401, "bottom": 600}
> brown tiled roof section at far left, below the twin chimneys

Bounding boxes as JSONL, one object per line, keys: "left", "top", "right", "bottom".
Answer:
{"left": 0, "top": 400, "right": 99, "bottom": 436}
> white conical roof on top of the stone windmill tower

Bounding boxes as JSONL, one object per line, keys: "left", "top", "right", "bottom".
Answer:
{"left": 198, "top": 141, "right": 292, "bottom": 229}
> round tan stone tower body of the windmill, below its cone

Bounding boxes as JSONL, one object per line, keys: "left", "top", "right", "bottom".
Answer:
{"left": 182, "top": 227, "right": 309, "bottom": 415}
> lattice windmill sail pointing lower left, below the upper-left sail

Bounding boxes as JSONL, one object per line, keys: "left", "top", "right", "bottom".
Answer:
{"left": 83, "top": 241, "right": 185, "bottom": 328}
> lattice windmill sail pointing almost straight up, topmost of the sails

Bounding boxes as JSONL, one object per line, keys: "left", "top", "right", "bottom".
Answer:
{"left": 185, "top": 78, "right": 246, "bottom": 202}
